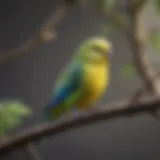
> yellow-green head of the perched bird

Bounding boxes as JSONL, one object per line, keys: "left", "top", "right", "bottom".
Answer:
{"left": 77, "top": 37, "right": 112, "bottom": 63}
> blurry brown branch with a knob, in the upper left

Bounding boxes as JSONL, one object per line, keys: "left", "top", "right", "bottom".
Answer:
{"left": 0, "top": 0, "right": 76, "bottom": 64}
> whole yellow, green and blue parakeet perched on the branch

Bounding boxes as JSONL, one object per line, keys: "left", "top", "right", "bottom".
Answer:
{"left": 44, "top": 37, "right": 112, "bottom": 120}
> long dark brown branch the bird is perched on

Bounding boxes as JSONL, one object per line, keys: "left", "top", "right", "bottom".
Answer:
{"left": 0, "top": 97, "right": 160, "bottom": 155}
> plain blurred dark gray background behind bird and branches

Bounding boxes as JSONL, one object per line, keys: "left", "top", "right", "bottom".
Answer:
{"left": 0, "top": 0, "right": 160, "bottom": 160}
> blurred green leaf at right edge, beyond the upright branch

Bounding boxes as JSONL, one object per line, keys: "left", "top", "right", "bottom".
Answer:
{"left": 149, "top": 31, "right": 160, "bottom": 53}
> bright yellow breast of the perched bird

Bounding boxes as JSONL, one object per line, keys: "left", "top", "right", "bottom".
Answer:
{"left": 83, "top": 64, "right": 109, "bottom": 101}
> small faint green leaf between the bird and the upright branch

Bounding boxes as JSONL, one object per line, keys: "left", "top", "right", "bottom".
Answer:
{"left": 121, "top": 62, "right": 136, "bottom": 78}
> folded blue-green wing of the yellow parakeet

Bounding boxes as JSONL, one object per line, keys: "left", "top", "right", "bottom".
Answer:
{"left": 51, "top": 62, "right": 82, "bottom": 107}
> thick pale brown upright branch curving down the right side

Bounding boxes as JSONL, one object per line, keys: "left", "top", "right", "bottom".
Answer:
{"left": 128, "top": 0, "right": 160, "bottom": 95}
